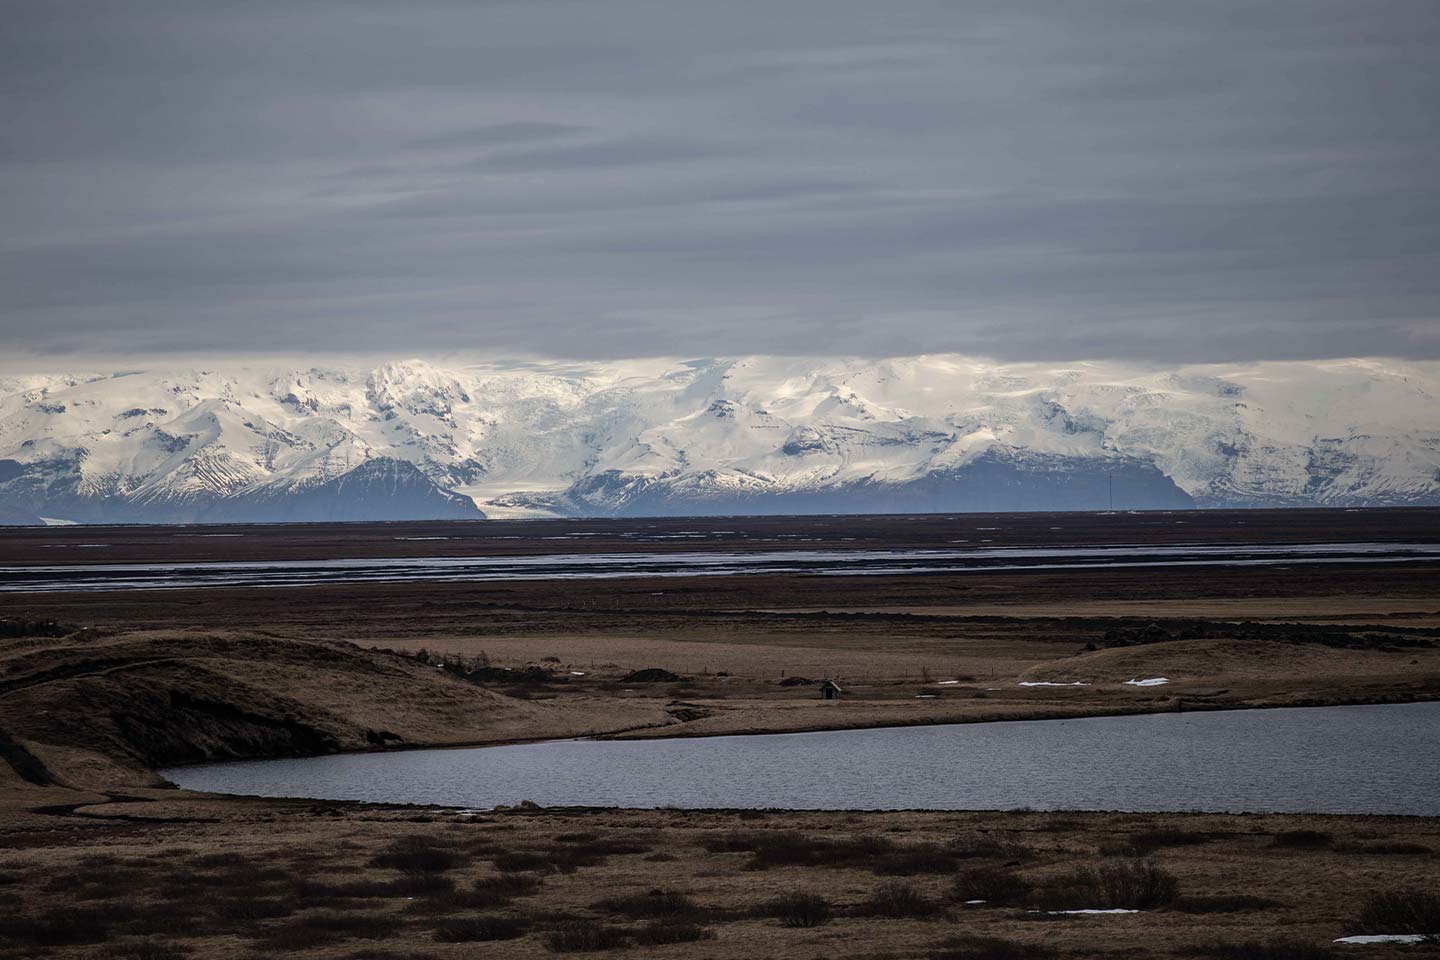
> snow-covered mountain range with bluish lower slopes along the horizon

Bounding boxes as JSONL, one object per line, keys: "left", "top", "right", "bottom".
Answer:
{"left": 0, "top": 356, "right": 1440, "bottom": 522}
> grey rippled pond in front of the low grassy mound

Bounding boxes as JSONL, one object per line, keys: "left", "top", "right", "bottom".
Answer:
{"left": 163, "top": 702, "right": 1440, "bottom": 816}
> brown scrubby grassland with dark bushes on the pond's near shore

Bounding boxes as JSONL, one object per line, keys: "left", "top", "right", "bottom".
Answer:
{"left": 0, "top": 787, "right": 1440, "bottom": 960}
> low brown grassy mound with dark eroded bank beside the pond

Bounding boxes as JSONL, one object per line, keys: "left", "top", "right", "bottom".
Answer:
{"left": 0, "top": 630, "right": 658, "bottom": 789}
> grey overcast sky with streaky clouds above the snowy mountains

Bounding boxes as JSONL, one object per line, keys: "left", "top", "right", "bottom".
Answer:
{"left": 0, "top": 0, "right": 1440, "bottom": 363}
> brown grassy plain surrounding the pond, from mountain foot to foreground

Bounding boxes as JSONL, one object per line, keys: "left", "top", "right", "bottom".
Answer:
{"left": 0, "top": 511, "right": 1440, "bottom": 960}
